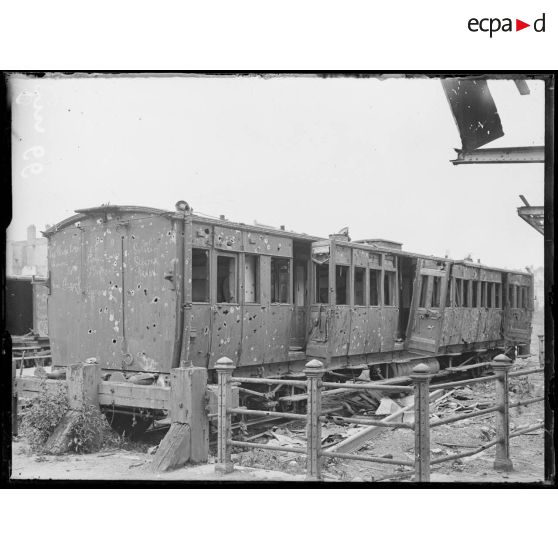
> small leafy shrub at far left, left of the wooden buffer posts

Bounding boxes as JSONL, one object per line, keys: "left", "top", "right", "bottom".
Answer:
{"left": 21, "top": 380, "right": 68, "bottom": 450}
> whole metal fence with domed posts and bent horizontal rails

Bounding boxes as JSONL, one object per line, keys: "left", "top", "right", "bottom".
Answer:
{"left": 215, "top": 355, "right": 544, "bottom": 482}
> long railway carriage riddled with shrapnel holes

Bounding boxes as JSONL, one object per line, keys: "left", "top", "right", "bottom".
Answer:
{"left": 44, "top": 202, "right": 533, "bottom": 434}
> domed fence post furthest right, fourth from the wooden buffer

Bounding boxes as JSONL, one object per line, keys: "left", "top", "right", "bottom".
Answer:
{"left": 490, "top": 354, "right": 513, "bottom": 471}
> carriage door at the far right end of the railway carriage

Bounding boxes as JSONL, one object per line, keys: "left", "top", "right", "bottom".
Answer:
{"left": 504, "top": 273, "right": 533, "bottom": 345}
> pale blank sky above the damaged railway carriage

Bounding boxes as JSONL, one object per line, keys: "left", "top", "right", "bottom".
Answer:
{"left": 8, "top": 76, "right": 544, "bottom": 269}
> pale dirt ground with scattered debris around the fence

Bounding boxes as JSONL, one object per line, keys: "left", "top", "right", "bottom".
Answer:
{"left": 11, "top": 321, "right": 544, "bottom": 483}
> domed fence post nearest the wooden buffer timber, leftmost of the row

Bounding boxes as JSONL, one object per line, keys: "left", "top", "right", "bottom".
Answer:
{"left": 215, "top": 357, "right": 235, "bottom": 474}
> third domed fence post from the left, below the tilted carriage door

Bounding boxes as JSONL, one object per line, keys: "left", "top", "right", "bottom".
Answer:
{"left": 411, "top": 363, "right": 432, "bottom": 482}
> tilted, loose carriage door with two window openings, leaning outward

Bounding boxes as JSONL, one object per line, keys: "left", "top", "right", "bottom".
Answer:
{"left": 408, "top": 258, "right": 449, "bottom": 352}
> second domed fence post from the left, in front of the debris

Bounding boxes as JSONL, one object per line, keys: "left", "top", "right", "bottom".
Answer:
{"left": 304, "top": 359, "right": 325, "bottom": 480}
